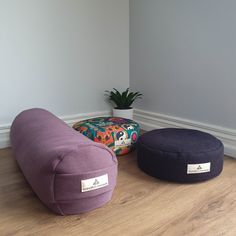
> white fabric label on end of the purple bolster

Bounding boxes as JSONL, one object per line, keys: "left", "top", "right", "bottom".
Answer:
{"left": 81, "top": 174, "right": 109, "bottom": 192}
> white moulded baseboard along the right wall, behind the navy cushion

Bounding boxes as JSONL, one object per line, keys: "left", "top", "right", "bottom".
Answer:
{"left": 134, "top": 109, "right": 236, "bottom": 158}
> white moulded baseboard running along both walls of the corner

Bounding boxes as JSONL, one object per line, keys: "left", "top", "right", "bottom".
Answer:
{"left": 0, "top": 109, "right": 236, "bottom": 158}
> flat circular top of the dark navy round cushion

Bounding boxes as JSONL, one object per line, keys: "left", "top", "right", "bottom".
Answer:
{"left": 139, "top": 128, "right": 222, "bottom": 153}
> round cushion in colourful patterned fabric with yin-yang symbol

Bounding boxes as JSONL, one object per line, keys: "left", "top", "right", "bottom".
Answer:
{"left": 73, "top": 117, "right": 140, "bottom": 155}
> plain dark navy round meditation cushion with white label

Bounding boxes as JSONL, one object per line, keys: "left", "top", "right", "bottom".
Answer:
{"left": 137, "top": 128, "right": 224, "bottom": 183}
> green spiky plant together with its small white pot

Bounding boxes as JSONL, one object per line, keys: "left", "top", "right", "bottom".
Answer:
{"left": 105, "top": 88, "right": 143, "bottom": 120}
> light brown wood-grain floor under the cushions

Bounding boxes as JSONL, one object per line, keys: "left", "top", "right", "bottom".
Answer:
{"left": 0, "top": 149, "right": 236, "bottom": 236}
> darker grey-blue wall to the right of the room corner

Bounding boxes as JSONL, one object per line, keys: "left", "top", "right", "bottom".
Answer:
{"left": 130, "top": 0, "right": 236, "bottom": 129}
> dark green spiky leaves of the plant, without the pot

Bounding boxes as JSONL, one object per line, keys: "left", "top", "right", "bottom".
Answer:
{"left": 105, "top": 88, "right": 143, "bottom": 109}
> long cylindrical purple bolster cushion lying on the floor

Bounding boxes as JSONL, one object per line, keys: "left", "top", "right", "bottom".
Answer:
{"left": 10, "top": 108, "right": 117, "bottom": 215}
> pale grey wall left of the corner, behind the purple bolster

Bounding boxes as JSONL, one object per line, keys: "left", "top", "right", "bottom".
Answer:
{"left": 0, "top": 0, "right": 129, "bottom": 126}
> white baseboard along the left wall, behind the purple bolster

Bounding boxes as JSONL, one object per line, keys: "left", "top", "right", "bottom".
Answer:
{"left": 0, "top": 111, "right": 111, "bottom": 149}
